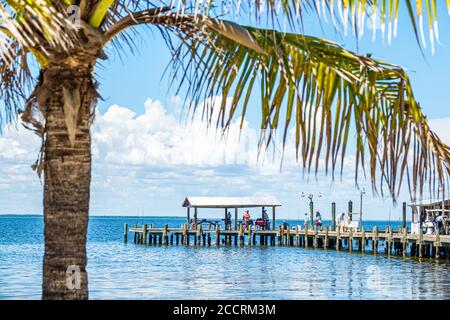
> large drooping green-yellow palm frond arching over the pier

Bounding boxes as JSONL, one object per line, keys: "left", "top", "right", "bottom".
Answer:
{"left": 152, "top": 14, "right": 450, "bottom": 199}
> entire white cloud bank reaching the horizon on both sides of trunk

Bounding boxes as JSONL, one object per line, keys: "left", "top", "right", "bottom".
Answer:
{"left": 0, "top": 97, "right": 450, "bottom": 219}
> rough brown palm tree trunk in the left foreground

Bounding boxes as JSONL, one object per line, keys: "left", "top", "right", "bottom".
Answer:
{"left": 37, "top": 70, "right": 96, "bottom": 299}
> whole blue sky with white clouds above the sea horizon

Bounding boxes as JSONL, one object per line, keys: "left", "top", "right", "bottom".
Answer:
{"left": 0, "top": 3, "right": 450, "bottom": 219}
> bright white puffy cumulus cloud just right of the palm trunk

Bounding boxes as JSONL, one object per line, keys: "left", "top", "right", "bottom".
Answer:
{"left": 93, "top": 98, "right": 256, "bottom": 167}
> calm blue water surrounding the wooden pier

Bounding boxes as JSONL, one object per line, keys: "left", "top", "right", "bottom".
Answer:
{"left": 0, "top": 216, "right": 450, "bottom": 299}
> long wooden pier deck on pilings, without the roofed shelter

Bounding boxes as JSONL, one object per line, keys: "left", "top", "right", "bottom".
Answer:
{"left": 123, "top": 224, "right": 450, "bottom": 260}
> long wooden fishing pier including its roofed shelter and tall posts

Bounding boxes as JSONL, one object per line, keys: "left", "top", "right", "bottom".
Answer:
{"left": 123, "top": 197, "right": 450, "bottom": 260}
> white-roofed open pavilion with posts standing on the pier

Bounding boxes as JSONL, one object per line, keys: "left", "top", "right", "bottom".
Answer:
{"left": 183, "top": 196, "right": 281, "bottom": 230}
